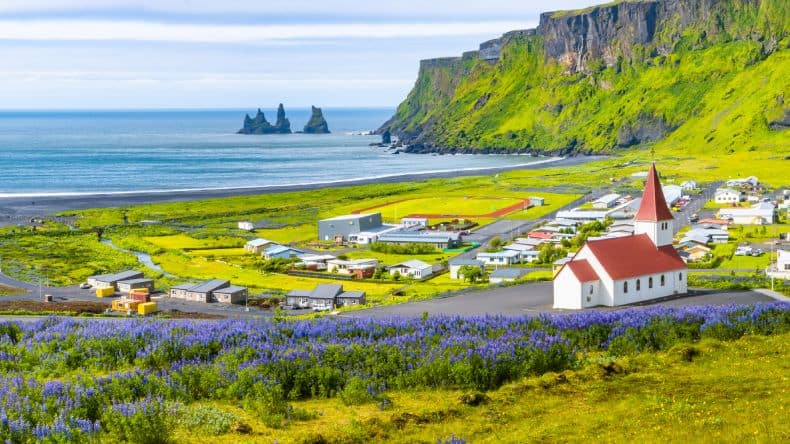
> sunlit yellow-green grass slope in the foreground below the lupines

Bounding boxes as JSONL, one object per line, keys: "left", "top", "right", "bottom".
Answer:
{"left": 170, "top": 334, "right": 790, "bottom": 444}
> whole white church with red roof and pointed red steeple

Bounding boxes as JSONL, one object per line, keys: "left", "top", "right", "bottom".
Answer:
{"left": 554, "top": 164, "right": 688, "bottom": 309}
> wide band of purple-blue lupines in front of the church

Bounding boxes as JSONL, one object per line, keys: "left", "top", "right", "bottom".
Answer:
{"left": 0, "top": 303, "right": 790, "bottom": 443}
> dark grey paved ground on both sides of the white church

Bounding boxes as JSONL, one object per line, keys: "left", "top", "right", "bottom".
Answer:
{"left": 343, "top": 282, "right": 775, "bottom": 318}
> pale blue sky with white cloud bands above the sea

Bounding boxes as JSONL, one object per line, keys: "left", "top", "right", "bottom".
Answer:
{"left": 0, "top": 0, "right": 601, "bottom": 110}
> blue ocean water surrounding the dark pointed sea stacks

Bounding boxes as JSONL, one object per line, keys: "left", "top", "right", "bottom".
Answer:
{"left": 0, "top": 107, "right": 536, "bottom": 197}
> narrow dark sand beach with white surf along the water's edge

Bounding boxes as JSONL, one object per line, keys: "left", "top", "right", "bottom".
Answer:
{"left": 0, "top": 156, "right": 605, "bottom": 220}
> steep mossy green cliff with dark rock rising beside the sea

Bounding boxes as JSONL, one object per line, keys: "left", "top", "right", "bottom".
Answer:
{"left": 381, "top": 0, "right": 790, "bottom": 154}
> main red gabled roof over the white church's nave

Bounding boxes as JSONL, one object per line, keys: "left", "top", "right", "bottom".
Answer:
{"left": 584, "top": 234, "right": 687, "bottom": 280}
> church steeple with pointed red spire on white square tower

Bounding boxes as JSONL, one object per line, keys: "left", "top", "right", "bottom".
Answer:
{"left": 634, "top": 163, "right": 675, "bottom": 247}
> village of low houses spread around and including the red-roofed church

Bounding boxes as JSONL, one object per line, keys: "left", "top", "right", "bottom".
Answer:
{"left": 58, "top": 166, "right": 790, "bottom": 314}
